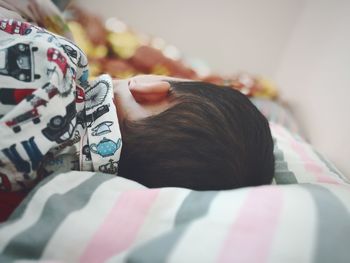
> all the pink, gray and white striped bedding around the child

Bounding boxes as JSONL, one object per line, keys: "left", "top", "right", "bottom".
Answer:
{"left": 0, "top": 122, "right": 350, "bottom": 263}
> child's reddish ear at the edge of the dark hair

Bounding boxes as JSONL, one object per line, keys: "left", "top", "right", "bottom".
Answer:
{"left": 129, "top": 81, "right": 170, "bottom": 103}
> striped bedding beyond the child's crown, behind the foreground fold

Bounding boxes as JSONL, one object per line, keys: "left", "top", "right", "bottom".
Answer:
{"left": 251, "top": 98, "right": 349, "bottom": 184}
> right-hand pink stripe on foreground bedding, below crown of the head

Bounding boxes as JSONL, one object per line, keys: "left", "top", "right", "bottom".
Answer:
{"left": 219, "top": 186, "right": 283, "bottom": 262}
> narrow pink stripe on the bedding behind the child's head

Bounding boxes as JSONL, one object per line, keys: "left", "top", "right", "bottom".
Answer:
{"left": 291, "top": 140, "right": 339, "bottom": 184}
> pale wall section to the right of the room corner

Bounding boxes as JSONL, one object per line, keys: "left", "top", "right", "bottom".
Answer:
{"left": 275, "top": 0, "right": 350, "bottom": 178}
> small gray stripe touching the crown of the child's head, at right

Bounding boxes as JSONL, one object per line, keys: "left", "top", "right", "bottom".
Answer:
{"left": 273, "top": 138, "right": 298, "bottom": 184}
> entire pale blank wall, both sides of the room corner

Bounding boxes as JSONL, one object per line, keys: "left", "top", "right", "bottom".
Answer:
{"left": 75, "top": 0, "right": 350, "bottom": 178}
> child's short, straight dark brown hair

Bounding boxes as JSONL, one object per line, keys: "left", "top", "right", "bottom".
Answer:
{"left": 119, "top": 82, "right": 274, "bottom": 190}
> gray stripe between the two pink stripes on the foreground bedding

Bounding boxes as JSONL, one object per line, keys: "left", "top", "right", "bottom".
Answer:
{"left": 126, "top": 191, "right": 218, "bottom": 263}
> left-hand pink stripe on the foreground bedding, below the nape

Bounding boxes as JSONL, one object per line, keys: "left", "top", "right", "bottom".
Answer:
{"left": 80, "top": 189, "right": 160, "bottom": 263}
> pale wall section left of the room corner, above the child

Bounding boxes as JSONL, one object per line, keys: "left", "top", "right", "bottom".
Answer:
{"left": 77, "top": 0, "right": 305, "bottom": 76}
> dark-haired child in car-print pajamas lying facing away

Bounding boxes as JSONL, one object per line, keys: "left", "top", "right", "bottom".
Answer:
{"left": 0, "top": 1, "right": 274, "bottom": 191}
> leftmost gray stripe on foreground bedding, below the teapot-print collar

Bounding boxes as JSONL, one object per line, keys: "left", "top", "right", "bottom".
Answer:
{"left": 3, "top": 173, "right": 114, "bottom": 259}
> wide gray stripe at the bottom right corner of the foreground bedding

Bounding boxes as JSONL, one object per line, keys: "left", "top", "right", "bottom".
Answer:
{"left": 303, "top": 184, "right": 350, "bottom": 263}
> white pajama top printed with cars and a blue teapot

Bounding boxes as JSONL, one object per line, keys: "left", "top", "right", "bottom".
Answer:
{"left": 0, "top": 19, "right": 121, "bottom": 191}
